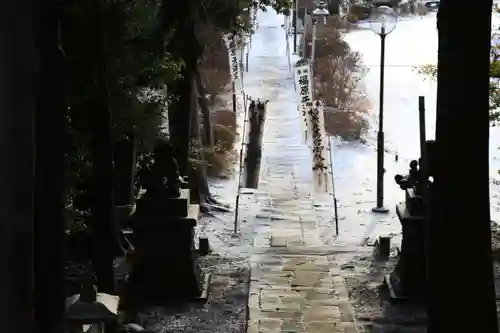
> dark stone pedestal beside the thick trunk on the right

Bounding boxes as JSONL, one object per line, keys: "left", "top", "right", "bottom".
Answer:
{"left": 385, "top": 200, "right": 426, "bottom": 300}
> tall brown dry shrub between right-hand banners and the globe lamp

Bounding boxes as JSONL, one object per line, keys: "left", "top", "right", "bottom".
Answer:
{"left": 306, "top": 16, "right": 369, "bottom": 140}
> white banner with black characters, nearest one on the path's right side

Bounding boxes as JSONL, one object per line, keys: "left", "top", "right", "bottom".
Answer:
{"left": 307, "top": 101, "right": 332, "bottom": 194}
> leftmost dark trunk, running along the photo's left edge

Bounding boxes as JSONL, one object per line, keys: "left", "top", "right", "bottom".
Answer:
{"left": 0, "top": 1, "right": 38, "bottom": 333}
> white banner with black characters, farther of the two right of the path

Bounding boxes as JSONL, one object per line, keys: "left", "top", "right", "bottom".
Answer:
{"left": 294, "top": 59, "right": 312, "bottom": 143}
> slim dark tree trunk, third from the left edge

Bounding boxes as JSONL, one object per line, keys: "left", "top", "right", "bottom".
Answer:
{"left": 89, "top": 0, "right": 120, "bottom": 293}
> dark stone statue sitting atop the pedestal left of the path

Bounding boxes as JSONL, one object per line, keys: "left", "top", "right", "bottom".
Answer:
{"left": 145, "top": 138, "right": 184, "bottom": 198}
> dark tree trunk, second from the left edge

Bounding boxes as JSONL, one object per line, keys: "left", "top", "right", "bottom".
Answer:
{"left": 34, "top": 0, "right": 67, "bottom": 333}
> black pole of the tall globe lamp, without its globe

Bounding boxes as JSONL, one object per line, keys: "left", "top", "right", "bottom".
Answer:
{"left": 372, "top": 27, "right": 389, "bottom": 213}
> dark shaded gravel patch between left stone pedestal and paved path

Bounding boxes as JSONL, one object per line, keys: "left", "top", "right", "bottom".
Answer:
{"left": 140, "top": 254, "right": 250, "bottom": 333}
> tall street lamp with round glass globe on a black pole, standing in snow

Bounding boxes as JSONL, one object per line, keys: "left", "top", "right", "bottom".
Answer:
{"left": 369, "top": 6, "right": 398, "bottom": 213}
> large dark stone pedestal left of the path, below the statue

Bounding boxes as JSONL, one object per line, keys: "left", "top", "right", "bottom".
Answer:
{"left": 123, "top": 190, "right": 203, "bottom": 308}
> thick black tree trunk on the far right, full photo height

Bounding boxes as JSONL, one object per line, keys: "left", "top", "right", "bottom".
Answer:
{"left": 428, "top": 0, "right": 498, "bottom": 333}
